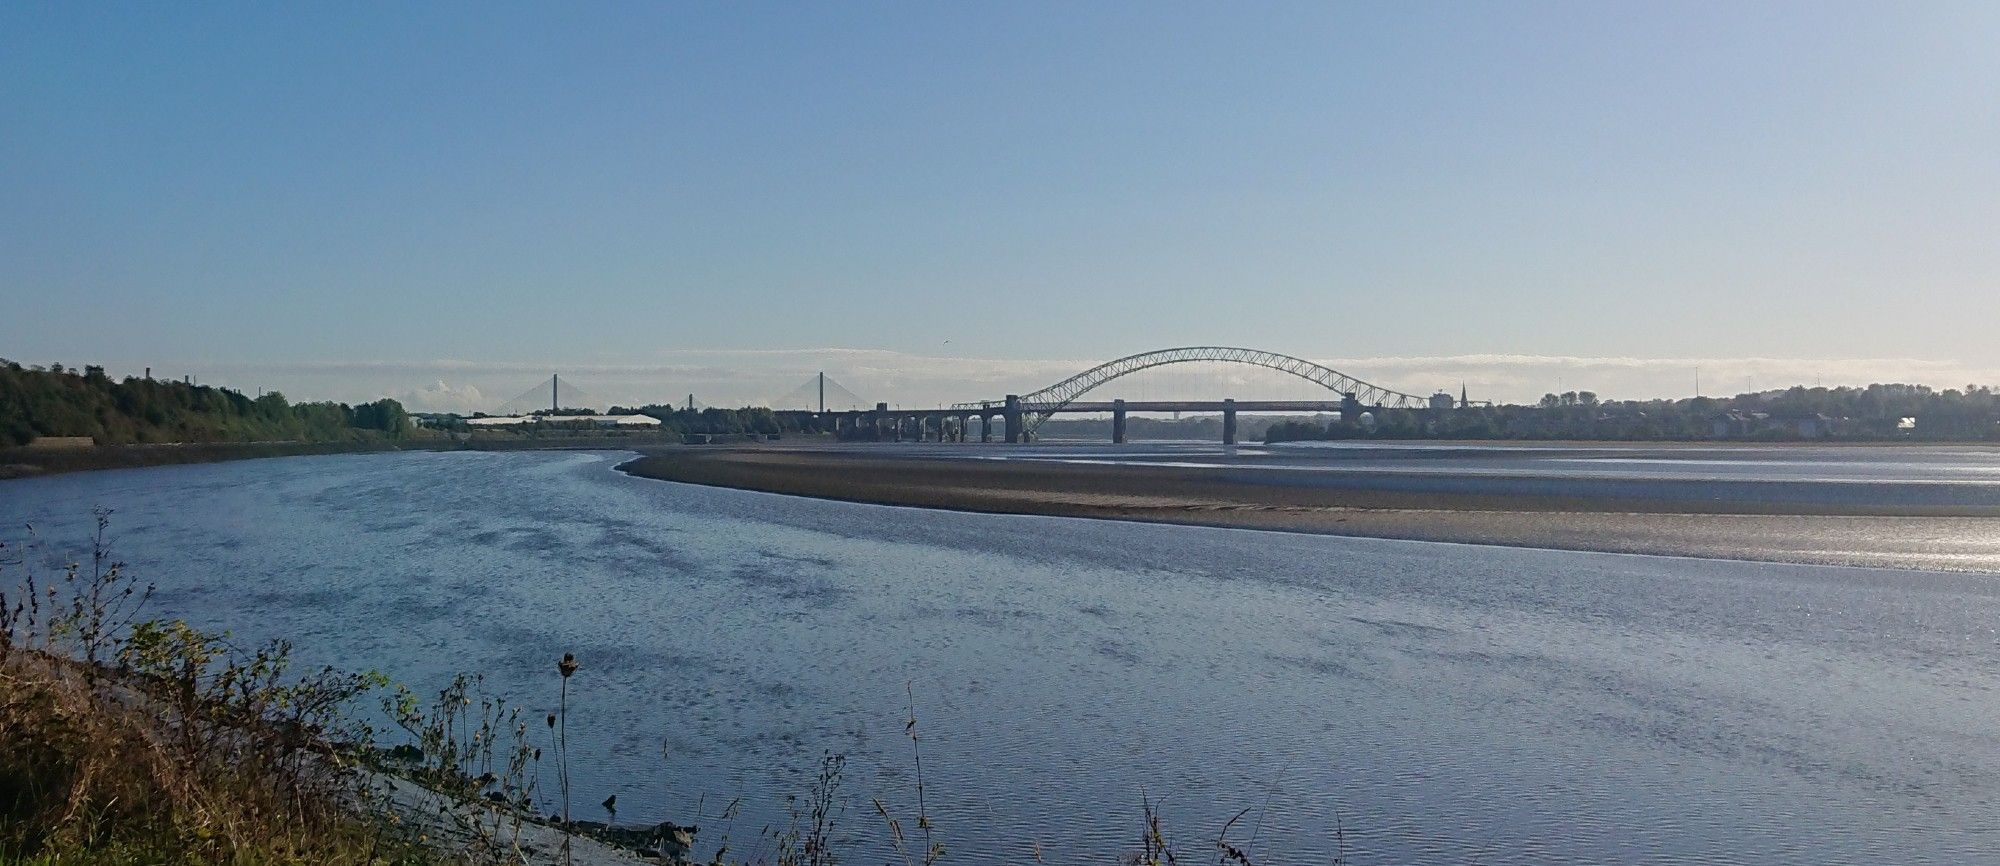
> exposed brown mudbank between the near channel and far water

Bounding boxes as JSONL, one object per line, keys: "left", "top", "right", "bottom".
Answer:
{"left": 620, "top": 448, "right": 2000, "bottom": 572}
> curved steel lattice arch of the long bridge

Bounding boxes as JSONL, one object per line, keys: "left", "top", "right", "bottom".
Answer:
{"left": 952, "top": 346, "right": 1426, "bottom": 432}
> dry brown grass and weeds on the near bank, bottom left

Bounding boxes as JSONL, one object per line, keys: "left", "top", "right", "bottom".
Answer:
{"left": 0, "top": 514, "right": 434, "bottom": 864}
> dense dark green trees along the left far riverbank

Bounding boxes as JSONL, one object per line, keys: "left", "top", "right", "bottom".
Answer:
{"left": 0, "top": 358, "right": 410, "bottom": 446}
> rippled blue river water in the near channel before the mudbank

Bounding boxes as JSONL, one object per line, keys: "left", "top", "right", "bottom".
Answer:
{"left": 0, "top": 452, "right": 2000, "bottom": 864}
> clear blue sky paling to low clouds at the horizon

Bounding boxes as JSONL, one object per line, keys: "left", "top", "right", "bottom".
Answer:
{"left": 0, "top": 0, "right": 2000, "bottom": 410}
